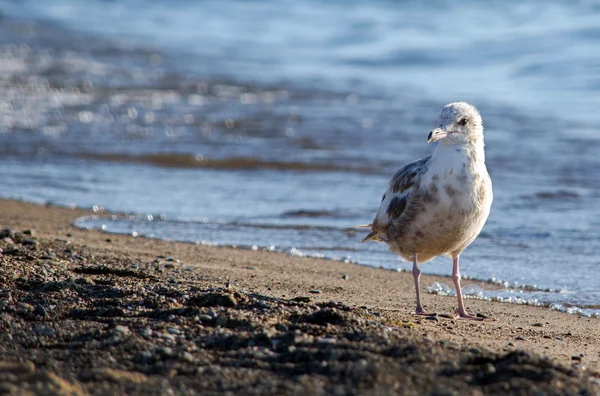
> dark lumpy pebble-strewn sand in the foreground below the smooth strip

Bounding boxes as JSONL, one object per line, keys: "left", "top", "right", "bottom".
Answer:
{"left": 0, "top": 232, "right": 600, "bottom": 395}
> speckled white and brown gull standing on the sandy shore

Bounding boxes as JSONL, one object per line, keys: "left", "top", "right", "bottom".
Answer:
{"left": 362, "top": 102, "right": 493, "bottom": 320}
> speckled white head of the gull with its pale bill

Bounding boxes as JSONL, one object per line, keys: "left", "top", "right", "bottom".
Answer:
{"left": 427, "top": 102, "right": 483, "bottom": 146}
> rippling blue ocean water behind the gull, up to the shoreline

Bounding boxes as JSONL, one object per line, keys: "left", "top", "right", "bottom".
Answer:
{"left": 0, "top": 0, "right": 600, "bottom": 315}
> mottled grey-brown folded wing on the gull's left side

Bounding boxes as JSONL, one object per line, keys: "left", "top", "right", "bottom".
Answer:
{"left": 363, "top": 156, "right": 431, "bottom": 242}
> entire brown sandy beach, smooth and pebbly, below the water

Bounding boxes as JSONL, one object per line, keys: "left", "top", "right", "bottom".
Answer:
{"left": 0, "top": 200, "right": 600, "bottom": 395}
